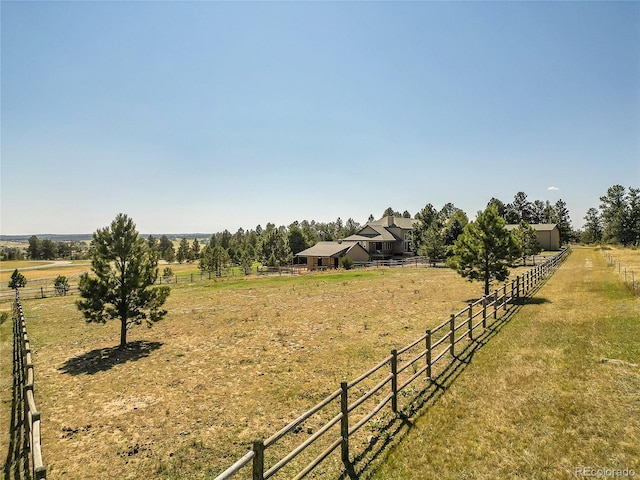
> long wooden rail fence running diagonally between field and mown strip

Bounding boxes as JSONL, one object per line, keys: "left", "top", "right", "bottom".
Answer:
{"left": 216, "top": 249, "right": 569, "bottom": 480}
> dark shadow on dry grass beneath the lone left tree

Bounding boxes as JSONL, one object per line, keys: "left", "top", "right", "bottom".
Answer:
{"left": 58, "top": 340, "right": 163, "bottom": 375}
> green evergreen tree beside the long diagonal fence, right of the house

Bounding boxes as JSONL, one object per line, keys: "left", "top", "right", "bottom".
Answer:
{"left": 447, "top": 205, "right": 521, "bottom": 295}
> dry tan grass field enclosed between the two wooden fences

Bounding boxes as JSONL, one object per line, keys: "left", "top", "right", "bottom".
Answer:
{"left": 0, "top": 262, "right": 540, "bottom": 479}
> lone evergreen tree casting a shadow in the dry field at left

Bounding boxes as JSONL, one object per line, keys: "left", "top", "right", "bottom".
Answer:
{"left": 76, "top": 213, "right": 170, "bottom": 348}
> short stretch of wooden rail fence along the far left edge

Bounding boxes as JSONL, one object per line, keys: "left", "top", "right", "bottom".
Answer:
{"left": 13, "top": 290, "right": 47, "bottom": 480}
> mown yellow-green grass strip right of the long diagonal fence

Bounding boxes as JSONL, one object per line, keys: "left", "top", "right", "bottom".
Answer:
{"left": 372, "top": 249, "right": 640, "bottom": 480}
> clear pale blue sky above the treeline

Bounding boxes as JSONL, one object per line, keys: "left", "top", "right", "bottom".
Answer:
{"left": 0, "top": 1, "right": 640, "bottom": 234}
